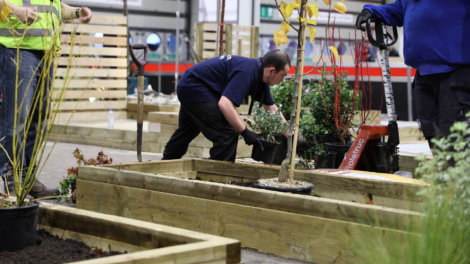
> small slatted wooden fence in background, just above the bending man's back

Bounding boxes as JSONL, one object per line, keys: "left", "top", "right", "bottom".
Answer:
{"left": 195, "top": 23, "right": 259, "bottom": 60}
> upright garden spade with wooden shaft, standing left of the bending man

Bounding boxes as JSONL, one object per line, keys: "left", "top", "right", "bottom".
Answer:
{"left": 129, "top": 44, "right": 148, "bottom": 162}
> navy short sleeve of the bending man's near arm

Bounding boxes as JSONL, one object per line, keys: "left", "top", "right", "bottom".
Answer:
{"left": 222, "top": 72, "right": 253, "bottom": 107}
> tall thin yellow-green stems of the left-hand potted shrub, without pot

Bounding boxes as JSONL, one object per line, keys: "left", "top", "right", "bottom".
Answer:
{"left": 0, "top": 9, "right": 75, "bottom": 207}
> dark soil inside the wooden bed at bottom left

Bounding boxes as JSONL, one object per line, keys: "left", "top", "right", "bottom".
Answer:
{"left": 0, "top": 230, "right": 123, "bottom": 264}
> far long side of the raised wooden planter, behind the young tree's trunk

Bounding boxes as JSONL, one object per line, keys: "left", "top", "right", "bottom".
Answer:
{"left": 196, "top": 160, "right": 422, "bottom": 210}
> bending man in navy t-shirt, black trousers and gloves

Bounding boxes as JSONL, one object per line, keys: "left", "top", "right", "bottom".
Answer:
{"left": 163, "top": 50, "right": 291, "bottom": 162}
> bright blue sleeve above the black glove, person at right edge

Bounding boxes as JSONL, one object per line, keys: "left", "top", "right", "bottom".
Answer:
{"left": 363, "top": 0, "right": 404, "bottom": 27}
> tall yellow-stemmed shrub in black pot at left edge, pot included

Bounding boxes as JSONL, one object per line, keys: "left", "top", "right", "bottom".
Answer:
{"left": 0, "top": 8, "right": 74, "bottom": 251}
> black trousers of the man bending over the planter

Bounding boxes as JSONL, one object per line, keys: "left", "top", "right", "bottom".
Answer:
{"left": 163, "top": 100, "right": 239, "bottom": 162}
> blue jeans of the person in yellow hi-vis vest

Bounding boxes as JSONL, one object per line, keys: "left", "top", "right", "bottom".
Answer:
{"left": 0, "top": 45, "right": 53, "bottom": 184}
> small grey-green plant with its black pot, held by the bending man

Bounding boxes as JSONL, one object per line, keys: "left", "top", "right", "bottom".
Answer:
{"left": 248, "top": 107, "right": 288, "bottom": 164}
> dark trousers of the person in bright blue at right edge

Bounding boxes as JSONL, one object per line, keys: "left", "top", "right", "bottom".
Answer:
{"left": 413, "top": 66, "right": 470, "bottom": 145}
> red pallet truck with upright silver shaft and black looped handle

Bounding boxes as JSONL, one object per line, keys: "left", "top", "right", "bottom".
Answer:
{"left": 339, "top": 19, "right": 400, "bottom": 174}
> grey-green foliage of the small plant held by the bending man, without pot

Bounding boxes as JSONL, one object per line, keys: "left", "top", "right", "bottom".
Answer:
{"left": 248, "top": 107, "right": 288, "bottom": 143}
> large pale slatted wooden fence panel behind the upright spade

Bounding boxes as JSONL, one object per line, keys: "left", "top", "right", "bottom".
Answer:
{"left": 53, "top": 15, "right": 128, "bottom": 122}
